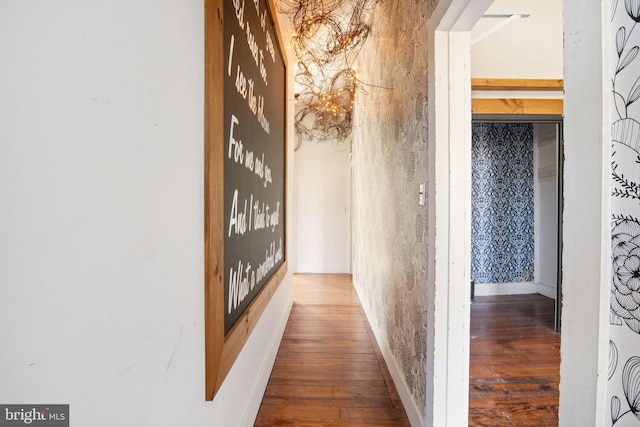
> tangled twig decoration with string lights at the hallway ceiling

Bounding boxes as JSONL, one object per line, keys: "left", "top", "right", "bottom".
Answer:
{"left": 279, "top": 0, "right": 380, "bottom": 149}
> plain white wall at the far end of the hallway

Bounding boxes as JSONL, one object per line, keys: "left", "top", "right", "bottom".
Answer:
{"left": 294, "top": 141, "right": 351, "bottom": 273}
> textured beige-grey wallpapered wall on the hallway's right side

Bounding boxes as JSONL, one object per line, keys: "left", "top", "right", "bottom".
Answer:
{"left": 353, "top": 0, "right": 436, "bottom": 417}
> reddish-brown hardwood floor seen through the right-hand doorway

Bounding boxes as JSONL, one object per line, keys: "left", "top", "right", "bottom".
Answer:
{"left": 469, "top": 295, "right": 560, "bottom": 427}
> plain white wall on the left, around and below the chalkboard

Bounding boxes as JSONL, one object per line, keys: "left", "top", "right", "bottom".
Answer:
{"left": 0, "top": 0, "right": 291, "bottom": 427}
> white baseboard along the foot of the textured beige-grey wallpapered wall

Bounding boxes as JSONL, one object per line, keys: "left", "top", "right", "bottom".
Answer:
{"left": 354, "top": 286, "right": 426, "bottom": 427}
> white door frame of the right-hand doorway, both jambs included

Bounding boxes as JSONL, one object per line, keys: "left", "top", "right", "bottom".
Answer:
{"left": 425, "top": 0, "right": 611, "bottom": 427}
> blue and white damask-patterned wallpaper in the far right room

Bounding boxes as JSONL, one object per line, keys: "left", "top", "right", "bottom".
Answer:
{"left": 471, "top": 123, "right": 534, "bottom": 283}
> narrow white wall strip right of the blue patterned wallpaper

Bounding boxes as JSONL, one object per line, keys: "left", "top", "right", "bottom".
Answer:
{"left": 533, "top": 123, "right": 558, "bottom": 299}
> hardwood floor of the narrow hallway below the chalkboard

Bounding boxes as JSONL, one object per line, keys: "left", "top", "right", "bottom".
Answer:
{"left": 255, "top": 274, "right": 409, "bottom": 427}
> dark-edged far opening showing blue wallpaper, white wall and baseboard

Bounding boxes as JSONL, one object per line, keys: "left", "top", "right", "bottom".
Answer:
{"left": 471, "top": 115, "right": 563, "bottom": 332}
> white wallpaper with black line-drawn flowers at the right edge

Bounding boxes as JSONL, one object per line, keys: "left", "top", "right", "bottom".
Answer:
{"left": 607, "top": 0, "right": 640, "bottom": 427}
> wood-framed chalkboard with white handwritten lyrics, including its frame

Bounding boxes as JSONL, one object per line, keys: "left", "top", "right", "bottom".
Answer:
{"left": 204, "top": 0, "right": 287, "bottom": 400}
